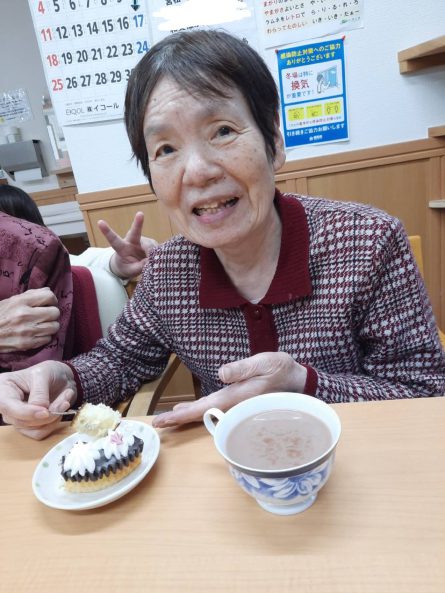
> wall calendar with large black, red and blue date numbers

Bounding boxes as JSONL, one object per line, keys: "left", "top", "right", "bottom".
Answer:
{"left": 29, "top": 0, "right": 150, "bottom": 125}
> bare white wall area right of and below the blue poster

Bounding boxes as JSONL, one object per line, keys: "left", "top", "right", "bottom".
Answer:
{"left": 267, "top": 0, "right": 445, "bottom": 160}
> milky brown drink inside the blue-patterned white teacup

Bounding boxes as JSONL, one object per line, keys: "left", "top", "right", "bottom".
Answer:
{"left": 226, "top": 410, "right": 332, "bottom": 470}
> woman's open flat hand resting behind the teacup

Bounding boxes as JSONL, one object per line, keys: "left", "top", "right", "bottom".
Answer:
{"left": 153, "top": 352, "right": 307, "bottom": 428}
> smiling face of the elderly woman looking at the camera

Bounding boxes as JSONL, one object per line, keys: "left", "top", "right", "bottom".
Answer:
{"left": 144, "top": 78, "right": 285, "bottom": 251}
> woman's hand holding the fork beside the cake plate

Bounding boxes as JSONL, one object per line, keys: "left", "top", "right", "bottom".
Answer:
{"left": 0, "top": 361, "right": 76, "bottom": 440}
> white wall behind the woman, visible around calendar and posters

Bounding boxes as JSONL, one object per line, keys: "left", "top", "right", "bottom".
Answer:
{"left": 0, "top": 0, "right": 445, "bottom": 193}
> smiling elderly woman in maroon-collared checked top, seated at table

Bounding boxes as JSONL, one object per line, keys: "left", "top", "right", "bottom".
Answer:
{"left": 0, "top": 31, "right": 445, "bottom": 438}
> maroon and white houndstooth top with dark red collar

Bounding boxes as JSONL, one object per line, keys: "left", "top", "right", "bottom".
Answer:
{"left": 70, "top": 191, "right": 445, "bottom": 403}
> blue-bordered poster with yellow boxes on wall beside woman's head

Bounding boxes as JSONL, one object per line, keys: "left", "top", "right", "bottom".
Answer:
{"left": 277, "top": 39, "right": 348, "bottom": 148}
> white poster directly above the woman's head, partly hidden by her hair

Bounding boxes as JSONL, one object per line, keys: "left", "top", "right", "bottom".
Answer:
{"left": 149, "top": 0, "right": 259, "bottom": 51}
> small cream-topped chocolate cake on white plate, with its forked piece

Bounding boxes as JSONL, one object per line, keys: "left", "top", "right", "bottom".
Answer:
{"left": 60, "top": 404, "right": 144, "bottom": 492}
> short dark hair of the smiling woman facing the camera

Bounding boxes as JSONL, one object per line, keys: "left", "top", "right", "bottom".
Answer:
{"left": 125, "top": 30, "right": 279, "bottom": 184}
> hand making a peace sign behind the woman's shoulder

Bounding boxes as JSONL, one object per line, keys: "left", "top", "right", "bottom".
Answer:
{"left": 97, "top": 212, "right": 158, "bottom": 279}
